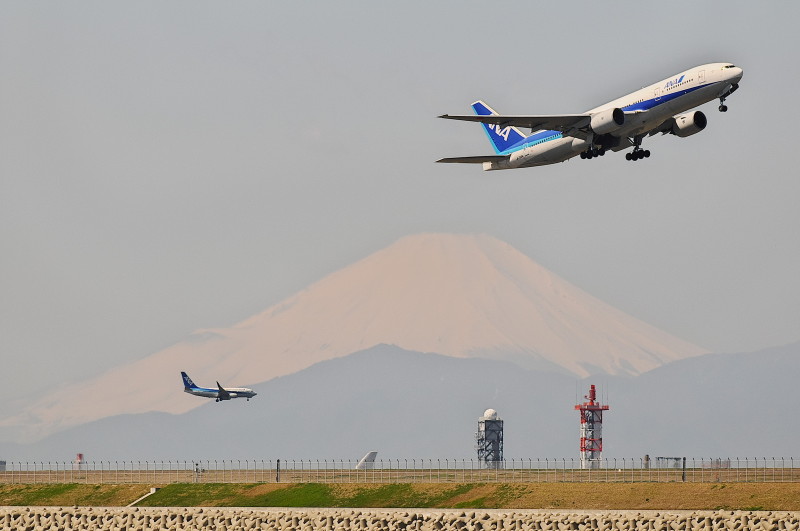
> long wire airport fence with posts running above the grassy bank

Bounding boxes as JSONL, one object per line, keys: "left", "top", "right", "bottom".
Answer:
{"left": 0, "top": 457, "right": 800, "bottom": 485}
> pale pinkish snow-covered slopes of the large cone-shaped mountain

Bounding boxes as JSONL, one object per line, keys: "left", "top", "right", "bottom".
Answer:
{"left": 0, "top": 234, "right": 706, "bottom": 440}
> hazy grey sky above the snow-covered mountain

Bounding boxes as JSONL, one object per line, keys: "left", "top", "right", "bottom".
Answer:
{"left": 0, "top": 0, "right": 800, "bottom": 400}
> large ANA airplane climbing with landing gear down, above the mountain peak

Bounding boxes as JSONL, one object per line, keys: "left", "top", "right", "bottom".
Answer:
{"left": 436, "top": 63, "right": 743, "bottom": 171}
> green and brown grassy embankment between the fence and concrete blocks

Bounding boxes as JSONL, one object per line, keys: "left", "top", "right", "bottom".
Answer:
{"left": 0, "top": 483, "right": 800, "bottom": 511}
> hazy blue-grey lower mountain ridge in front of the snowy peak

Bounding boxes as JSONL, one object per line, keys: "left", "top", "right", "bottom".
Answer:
{"left": 0, "top": 343, "right": 800, "bottom": 461}
